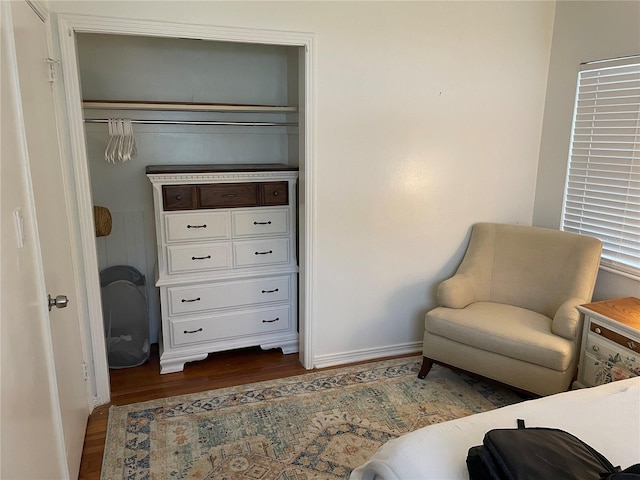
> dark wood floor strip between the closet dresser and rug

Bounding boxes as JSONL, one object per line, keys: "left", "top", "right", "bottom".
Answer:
{"left": 79, "top": 348, "right": 408, "bottom": 480}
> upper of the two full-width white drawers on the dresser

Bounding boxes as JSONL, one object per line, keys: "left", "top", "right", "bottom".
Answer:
{"left": 167, "top": 276, "right": 291, "bottom": 316}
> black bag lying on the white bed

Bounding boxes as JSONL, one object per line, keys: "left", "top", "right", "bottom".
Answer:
{"left": 467, "top": 420, "right": 640, "bottom": 480}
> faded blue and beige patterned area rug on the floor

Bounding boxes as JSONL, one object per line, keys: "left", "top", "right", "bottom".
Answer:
{"left": 102, "top": 357, "right": 522, "bottom": 480}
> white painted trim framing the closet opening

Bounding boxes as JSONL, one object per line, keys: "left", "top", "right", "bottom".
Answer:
{"left": 58, "top": 14, "right": 316, "bottom": 405}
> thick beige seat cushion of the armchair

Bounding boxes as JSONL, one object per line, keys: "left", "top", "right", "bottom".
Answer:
{"left": 425, "top": 302, "right": 573, "bottom": 371}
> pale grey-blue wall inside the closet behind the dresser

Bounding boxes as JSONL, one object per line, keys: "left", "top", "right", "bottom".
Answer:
{"left": 78, "top": 34, "right": 298, "bottom": 342}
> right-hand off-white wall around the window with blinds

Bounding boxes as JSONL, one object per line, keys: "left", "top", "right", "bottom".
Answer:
{"left": 533, "top": 1, "right": 640, "bottom": 300}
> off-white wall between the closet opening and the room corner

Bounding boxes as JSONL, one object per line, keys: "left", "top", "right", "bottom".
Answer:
{"left": 51, "top": 1, "right": 554, "bottom": 364}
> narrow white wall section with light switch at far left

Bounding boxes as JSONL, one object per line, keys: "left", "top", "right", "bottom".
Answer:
{"left": 0, "top": 2, "right": 67, "bottom": 478}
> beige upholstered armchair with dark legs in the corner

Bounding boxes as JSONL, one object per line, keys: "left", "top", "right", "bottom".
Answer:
{"left": 418, "top": 223, "right": 602, "bottom": 395}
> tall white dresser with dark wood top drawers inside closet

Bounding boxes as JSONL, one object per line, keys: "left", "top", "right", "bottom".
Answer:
{"left": 146, "top": 164, "right": 298, "bottom": 373}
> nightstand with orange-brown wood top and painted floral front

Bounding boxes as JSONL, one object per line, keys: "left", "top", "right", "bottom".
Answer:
{"left": 574, "top": 297, "right": 640, "bottom": 388}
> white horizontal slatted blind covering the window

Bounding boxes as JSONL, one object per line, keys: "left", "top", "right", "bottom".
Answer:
{"left": 562, "top": 56, "right": 640, "bottom": 278}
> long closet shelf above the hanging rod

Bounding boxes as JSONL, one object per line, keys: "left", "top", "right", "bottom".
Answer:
{"left": 82, "top": 100, "right": 298, "bottom": 113}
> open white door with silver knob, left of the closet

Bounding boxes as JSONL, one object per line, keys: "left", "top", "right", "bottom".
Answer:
{"left": 2, "top": 1, "right": 89, "bottom": 478}
